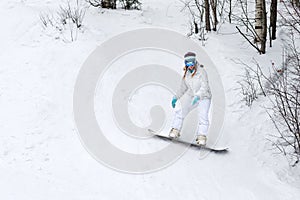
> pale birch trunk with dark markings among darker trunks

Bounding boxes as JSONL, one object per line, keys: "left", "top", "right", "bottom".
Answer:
{"left": 255, "top": 0, "right": 267, "bottom": 54}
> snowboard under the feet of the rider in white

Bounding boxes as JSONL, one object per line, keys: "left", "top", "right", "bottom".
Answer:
{"left": 148, "top": 129, "right": 228, "bottom": 153}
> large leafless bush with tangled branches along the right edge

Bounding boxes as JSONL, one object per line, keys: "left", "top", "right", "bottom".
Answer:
{"left": 269, "top": 47, "right": 300, "bottom": 165}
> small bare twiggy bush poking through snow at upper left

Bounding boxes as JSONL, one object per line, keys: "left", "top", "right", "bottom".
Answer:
{"left": 40, "top": 0, "right": 87, "bottom": 42}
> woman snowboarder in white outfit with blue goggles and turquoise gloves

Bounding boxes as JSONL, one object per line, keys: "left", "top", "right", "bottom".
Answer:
{"left": 169, "top": 52, "right": 212, "bottom": 145}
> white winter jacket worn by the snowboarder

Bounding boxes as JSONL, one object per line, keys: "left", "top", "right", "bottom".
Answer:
{"left": 176, "top": 64, "right": 212, "bottom": 100}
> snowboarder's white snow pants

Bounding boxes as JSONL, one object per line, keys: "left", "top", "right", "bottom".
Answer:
{"left": 172, "top": 96, "right": 211, "bottom": 136}
